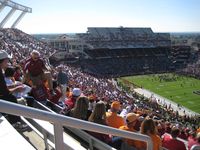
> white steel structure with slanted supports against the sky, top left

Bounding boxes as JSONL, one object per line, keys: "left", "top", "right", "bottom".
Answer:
{"left": 0, "top": 0, "right": 32, "bottom": 28}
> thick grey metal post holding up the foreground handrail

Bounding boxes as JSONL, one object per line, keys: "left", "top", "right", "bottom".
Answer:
{"left": 54, "top": 122, "right": 64, "bottom": 150}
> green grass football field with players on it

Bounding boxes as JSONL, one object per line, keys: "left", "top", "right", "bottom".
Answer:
{"left": 122, "top": 74, "right": 200, "bottom": 113}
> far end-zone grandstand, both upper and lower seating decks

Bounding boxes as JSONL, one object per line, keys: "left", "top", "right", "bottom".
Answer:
{"left": 77, "top": 27, "right": 173, "bottom": 76}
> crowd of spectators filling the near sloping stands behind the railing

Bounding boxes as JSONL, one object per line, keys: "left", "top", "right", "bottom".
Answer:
{"left": 0, "top": 29, "right": 200, "bottom": 150}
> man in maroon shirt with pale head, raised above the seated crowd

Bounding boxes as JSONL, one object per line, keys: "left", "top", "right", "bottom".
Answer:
{"left": 24, "top": 50, "right": 55, "bottom": 95}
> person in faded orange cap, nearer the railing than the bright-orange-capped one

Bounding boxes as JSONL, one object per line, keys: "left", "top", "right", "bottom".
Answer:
{"left": 119, "top": 113, "right": 140, "bottom": 149}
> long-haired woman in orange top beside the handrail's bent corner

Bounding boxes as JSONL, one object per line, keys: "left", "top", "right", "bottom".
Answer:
{"left": 140, "top": 117, "right": 162, "bottom": 150}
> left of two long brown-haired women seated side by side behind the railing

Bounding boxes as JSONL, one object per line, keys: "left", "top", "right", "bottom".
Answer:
{"left": 69, "top": 97, "right": 89, "bottom": 120}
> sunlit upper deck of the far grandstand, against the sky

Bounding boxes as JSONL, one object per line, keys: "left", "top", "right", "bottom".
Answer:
{"left": 77, "top": 27, "right": 171, "bottom": 49}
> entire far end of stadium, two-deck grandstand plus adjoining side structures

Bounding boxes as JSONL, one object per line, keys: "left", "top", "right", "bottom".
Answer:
{"left": 49, "top": 27, "right": 190, "bottom": 77}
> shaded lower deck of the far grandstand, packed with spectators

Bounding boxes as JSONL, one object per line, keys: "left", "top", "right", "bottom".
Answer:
{"left": 81, "top": 48, "right": 172, "bottom": 77}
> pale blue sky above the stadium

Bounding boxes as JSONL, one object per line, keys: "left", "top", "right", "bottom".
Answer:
{"left": 0, "top": 0, "right": 200, "bottom": 33}
